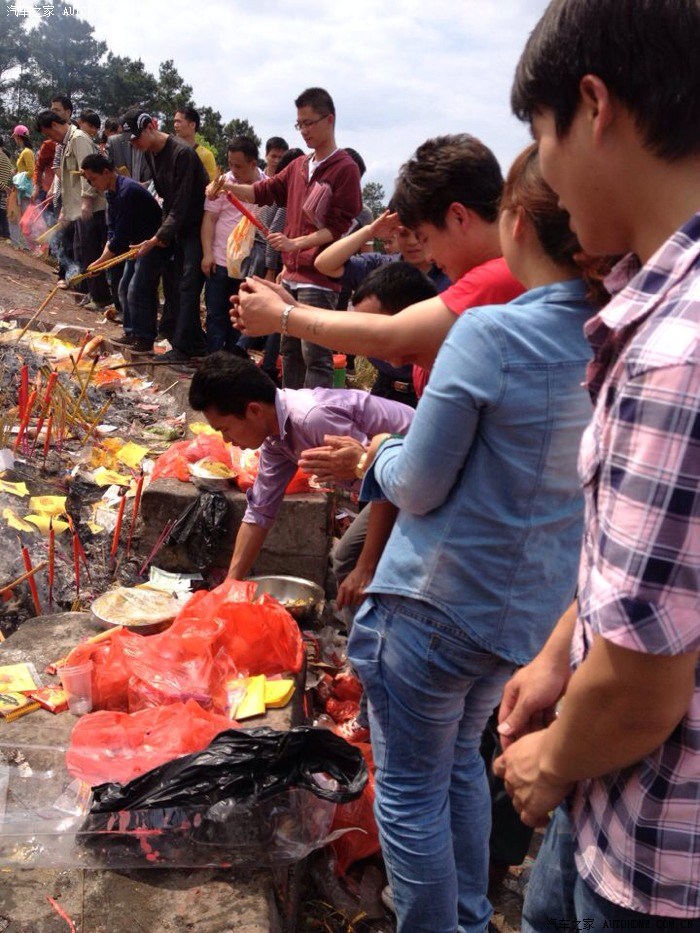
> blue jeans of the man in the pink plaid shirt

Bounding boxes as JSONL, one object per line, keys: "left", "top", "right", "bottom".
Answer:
{"left": 520, "top": 806, "right": 700, "bottom": 933}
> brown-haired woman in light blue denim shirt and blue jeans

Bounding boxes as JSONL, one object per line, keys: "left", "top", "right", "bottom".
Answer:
{"left": 349, "top": 146, "right": 608, "bottom": 933}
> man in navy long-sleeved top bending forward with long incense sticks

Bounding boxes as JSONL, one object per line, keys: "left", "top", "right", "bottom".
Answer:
{"left": 80, "top": 153, "right": 162, "bottom": 353}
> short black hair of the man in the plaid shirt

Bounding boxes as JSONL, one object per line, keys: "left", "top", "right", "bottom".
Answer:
{"left": 511, "top": 0, "right": 700, "bottom": 160}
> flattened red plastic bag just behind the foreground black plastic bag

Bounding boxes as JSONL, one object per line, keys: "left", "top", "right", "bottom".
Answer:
{"left": 66, "top": 700, "right": 234, "bottom": 787}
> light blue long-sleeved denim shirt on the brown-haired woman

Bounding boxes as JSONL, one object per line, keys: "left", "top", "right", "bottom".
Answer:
{"left": 361, "top": 280, "right": 594, "bottom": 664}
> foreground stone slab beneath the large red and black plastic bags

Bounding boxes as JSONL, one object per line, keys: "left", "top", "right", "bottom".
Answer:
{"left": 0, "top": 612, "right": 302, "bottom": 933}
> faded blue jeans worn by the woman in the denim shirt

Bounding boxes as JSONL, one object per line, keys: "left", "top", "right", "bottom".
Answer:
{"left": 348, "top": 595, "right": 513, "bottom": 933}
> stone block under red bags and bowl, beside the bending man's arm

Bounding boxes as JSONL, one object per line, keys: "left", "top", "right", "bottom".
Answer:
{"left": 140, "top": 479, "right": 332, "bottom": 586}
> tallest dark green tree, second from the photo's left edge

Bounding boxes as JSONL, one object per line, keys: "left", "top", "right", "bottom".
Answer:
{"left": 24, "top": 0, "right": 107, "bottom": 110}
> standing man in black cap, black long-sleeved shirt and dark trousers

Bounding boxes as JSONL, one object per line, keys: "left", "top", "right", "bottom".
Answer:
{"left": 120, "top": 107, "right": 207, "bottom": 363}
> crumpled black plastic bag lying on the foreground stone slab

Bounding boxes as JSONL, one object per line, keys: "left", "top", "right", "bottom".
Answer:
{"left": 90, "top": 726, "right": 368, "bottom": 814}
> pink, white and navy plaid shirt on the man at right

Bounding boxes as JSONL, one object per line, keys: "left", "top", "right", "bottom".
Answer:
{"left": 572, "top": 214, "right": 700, "bottom": 917}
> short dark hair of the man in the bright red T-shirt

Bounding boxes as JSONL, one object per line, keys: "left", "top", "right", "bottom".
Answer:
{"left": 391, "top": 133, "right": 503, "bottom": 230}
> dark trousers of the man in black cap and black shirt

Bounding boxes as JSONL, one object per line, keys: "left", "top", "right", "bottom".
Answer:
{"left": 170, "top": 226, "right": 207, "bottom": 356}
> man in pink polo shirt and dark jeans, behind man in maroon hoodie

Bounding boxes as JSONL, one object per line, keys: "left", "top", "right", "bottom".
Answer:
{"left": 201, "top": 136, "right": 266, "bottom": 353}
